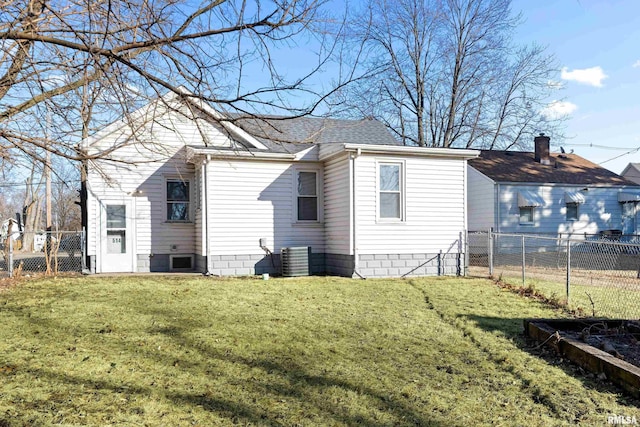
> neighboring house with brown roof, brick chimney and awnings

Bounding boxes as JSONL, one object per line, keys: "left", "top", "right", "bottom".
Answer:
{"left": 468, "top": 134, "right": 640, "bottom": 235}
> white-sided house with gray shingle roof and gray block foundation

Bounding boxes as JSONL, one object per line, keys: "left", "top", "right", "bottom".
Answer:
{"left": 84, "top": 90, "right": 478, "bottom": 277}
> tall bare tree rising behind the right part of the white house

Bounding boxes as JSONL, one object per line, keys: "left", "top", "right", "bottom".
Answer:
{"left": 341, "top": 0, "right": 561, "bottom": 149}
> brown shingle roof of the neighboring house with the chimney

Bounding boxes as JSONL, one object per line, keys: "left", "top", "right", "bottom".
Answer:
{"left": 469, "top": 150, "right": 637, "bottom": 186}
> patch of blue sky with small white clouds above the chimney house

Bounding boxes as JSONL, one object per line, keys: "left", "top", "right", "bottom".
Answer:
{"left": 512, "top": 0, "right": 640, "bottom": 173}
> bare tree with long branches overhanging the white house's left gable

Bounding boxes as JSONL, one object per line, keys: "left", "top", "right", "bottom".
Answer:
{"left": 0, "top": 0, "right": 353, "bottom": 171}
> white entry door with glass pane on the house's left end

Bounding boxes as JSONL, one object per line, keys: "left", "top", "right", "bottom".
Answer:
{"left": 100, "top": 200, "right": 134, "bottom": 273}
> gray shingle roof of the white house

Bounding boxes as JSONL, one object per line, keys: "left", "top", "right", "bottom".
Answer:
{"left": 222, "top": 116, "right": 402, "bottom": 153}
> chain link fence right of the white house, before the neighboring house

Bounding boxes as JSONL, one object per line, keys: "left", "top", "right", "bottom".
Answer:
{"left": 468, "top": 232, "right": 640, "bottom": 319}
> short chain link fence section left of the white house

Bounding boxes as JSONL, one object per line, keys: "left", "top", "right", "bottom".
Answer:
{"left": 0, "top": 231, "right": 85, "bottom": 277}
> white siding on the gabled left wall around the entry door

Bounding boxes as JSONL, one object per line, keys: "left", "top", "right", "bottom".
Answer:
{"left": 87, "top": 103, "right": 212, "bottom": 255}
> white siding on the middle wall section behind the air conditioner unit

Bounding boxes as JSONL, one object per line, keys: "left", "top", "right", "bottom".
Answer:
{"left": 207, "top": 160, "right": 325, "bottom": 255}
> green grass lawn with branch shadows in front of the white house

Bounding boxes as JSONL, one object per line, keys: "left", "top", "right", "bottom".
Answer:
{"left": 0, "top": 276, "right": 640, "bottom": 426}
